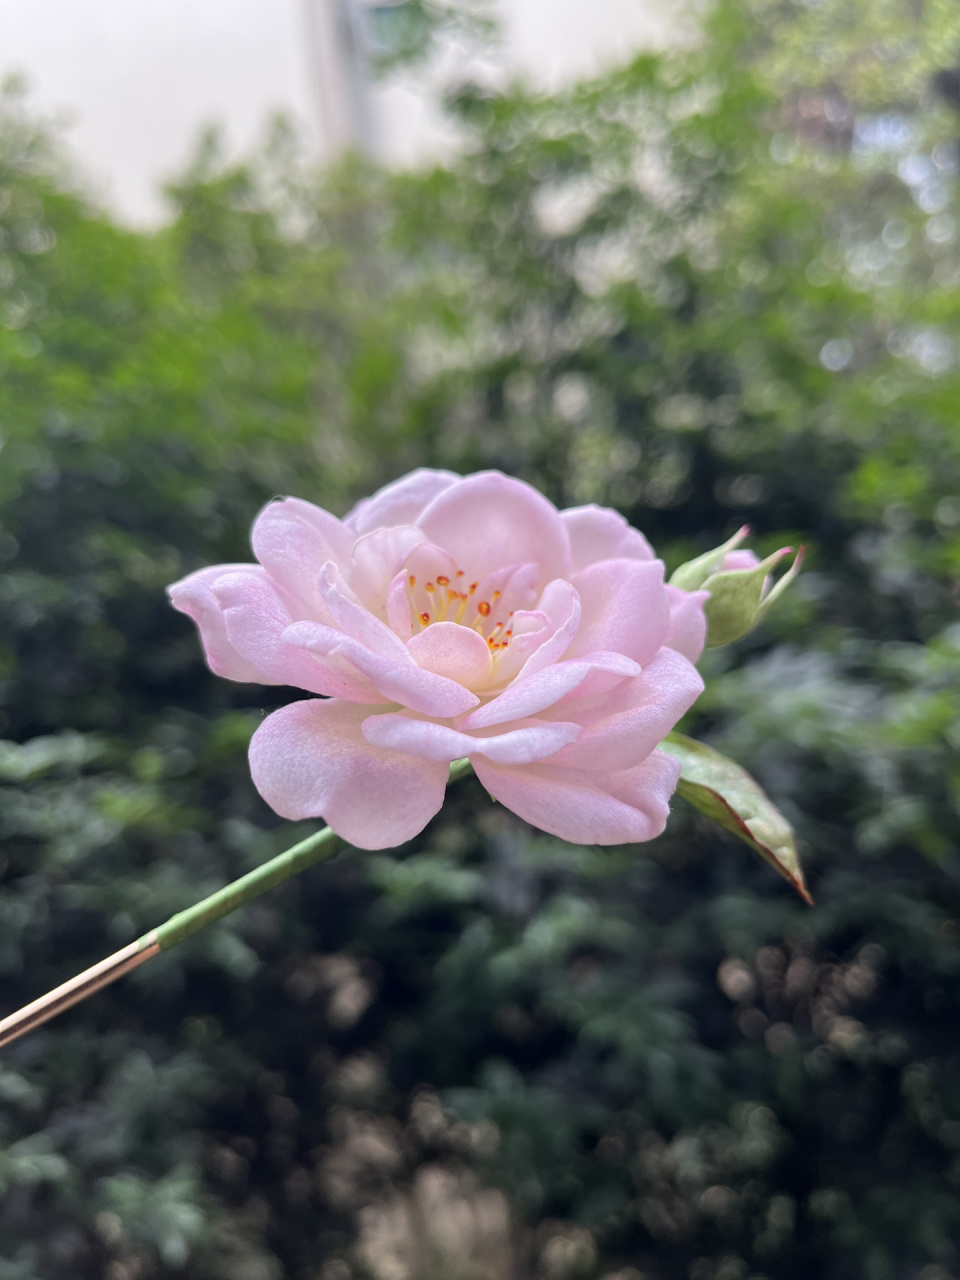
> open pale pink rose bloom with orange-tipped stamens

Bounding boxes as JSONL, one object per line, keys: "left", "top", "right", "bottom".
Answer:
{"left": 169, "top": 470, "right": 707, "bottom": 849}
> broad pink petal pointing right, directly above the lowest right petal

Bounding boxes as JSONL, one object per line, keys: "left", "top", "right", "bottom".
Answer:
{"left": 550, "top": 649, "right": 703, "bottom": 773}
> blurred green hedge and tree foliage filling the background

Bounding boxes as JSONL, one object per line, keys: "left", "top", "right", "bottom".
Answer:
{"left": 0, "top": 0, "right": 960, "bottom": 1280}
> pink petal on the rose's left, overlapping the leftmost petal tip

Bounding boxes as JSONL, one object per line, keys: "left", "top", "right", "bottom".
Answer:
{"left": 212, "top": 576, "right": 385, "bottom": 704}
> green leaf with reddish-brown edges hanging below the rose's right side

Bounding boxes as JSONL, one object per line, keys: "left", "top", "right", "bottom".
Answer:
{"left": 663, "top": 733, "right": 813, "bottom": 906}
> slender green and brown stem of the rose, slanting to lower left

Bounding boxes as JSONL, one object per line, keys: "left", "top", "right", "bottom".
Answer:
{"left": 0, "top": 760, "right": 470, "bottom": 1048}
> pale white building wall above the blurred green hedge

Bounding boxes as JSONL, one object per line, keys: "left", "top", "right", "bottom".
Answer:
{"left": 0, "top": 0, "right": 672, "bottom": 224}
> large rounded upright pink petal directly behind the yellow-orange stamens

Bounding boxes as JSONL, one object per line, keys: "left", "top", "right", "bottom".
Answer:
{"left": 417, "top": 471, "right": 570, "bottom": 582}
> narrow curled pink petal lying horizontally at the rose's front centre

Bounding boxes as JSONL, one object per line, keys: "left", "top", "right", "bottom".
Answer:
{"left": 364, "top": 713, "right": 580, "bottom": 764}
